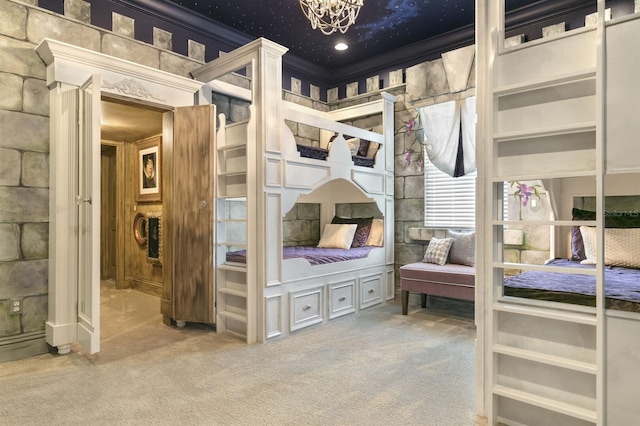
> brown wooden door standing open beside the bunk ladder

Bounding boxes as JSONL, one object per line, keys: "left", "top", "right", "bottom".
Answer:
{"left": 171, "top": 105, "right": 215, "bottom": 323}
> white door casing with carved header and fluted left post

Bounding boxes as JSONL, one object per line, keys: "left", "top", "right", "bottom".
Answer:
{"left": 36, "top": 39, "right": 202, "bottom": 354}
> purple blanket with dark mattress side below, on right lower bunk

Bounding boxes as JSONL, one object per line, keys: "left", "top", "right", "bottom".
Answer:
{"left": 504, "top": 259, "right": 640, "bottom": 312}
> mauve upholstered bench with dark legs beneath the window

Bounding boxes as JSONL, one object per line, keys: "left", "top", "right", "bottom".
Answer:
{"left": 400, "top": 262, "right": 475, "bottom": 315}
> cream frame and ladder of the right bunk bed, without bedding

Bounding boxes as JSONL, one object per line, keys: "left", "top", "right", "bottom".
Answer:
{"left": 476, "top": 0, "right": 640, "bottom": 425}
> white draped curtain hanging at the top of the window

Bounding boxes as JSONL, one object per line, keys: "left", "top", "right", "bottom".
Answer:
{"left": 419, "top": 96, "right": 476, "bottom": 176}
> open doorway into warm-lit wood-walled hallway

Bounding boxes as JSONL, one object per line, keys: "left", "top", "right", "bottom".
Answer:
{"left": 100, "top": 97, "right": 165, "bottom": 341}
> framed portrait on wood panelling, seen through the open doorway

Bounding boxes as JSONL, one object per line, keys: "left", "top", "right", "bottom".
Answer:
{"left": 136, "top": 136, "right": 162, "bottom": 202}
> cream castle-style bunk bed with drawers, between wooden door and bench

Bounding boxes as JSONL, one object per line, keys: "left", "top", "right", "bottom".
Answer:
{"left": 192, "top": 39, "right": 395, "bottom": 343}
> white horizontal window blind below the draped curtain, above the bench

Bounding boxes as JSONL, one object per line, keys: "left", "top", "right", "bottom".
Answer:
{"left": 424, "top": 160, "right": 477, "bottom": 229}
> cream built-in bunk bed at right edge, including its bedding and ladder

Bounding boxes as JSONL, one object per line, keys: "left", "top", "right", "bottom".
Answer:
{"left": 476, "top": 0, "right": 640, "bottom": 426}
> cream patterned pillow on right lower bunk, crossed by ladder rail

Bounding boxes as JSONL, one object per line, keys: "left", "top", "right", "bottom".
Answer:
{"left": 580, "top": 226, "right": 640, "bottom": 268}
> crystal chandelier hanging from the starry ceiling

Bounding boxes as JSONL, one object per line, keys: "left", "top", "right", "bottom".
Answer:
{"left": 300, "top": 0, "right": 364, "bottom": 35}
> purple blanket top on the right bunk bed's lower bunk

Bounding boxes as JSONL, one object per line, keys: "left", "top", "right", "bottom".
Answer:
{"left": 504, "top": 259, "right": 640, "bottom": 303}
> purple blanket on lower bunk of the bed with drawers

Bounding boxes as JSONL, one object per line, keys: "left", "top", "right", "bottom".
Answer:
{"left": 227, "top": 246, "right": 374, "bottom": 265}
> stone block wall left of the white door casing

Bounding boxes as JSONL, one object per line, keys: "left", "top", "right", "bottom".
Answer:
{"left": 0, "top": 1, "right": 49, "bottom": 361}
